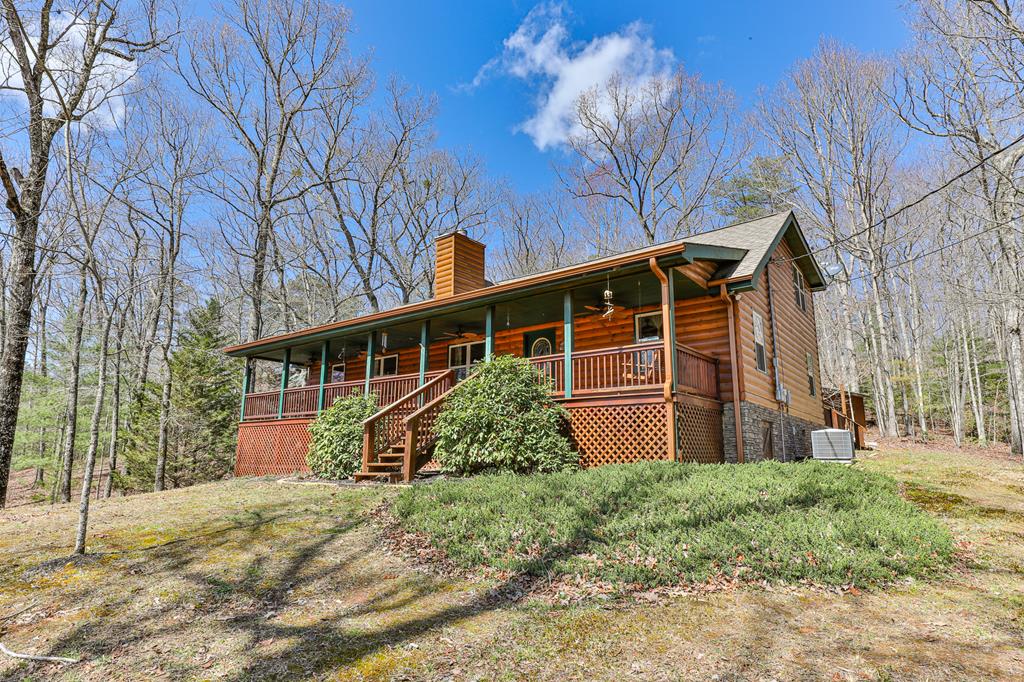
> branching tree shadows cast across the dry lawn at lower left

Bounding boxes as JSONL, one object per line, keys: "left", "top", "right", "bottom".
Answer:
{"left": 4, "top": 485, "right": 614, "bottom": 680}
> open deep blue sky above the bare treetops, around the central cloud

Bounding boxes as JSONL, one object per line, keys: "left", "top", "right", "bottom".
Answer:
{"left": 345, "top": 0, "right": 908, "bottom": 191}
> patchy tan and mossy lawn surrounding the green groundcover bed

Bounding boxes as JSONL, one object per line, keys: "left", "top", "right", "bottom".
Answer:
{"left": 0, "top": 450, "right": 1024, "bottom": 680}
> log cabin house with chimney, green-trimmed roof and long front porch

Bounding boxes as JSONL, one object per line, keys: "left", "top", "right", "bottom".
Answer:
{"left": 225, "top": 212, "right": 826, "bottom": 480}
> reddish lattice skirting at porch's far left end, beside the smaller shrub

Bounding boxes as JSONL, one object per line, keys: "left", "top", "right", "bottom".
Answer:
{"left": 234, "top": 419, "right": 309, "bottom": 476}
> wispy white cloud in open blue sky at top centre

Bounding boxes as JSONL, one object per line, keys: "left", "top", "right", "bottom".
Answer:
{"left": 472, "top": 4, "right": 676, "bottom": 150}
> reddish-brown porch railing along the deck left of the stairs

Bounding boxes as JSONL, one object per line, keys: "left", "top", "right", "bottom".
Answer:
{"left": 243, "top": 371, "right": 443, "bottom": 421}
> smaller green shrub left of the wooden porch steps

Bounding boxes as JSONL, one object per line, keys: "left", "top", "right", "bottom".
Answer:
{"left": 306, "top": 393, "right": 377, "bottom": 480}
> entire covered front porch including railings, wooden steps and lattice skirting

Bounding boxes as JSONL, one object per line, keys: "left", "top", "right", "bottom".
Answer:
{"left": 237, "top": 246, "right": 734, "bottom": 479}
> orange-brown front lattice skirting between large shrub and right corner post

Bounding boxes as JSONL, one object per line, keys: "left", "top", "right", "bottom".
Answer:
{"left": 565, "top": 397, "right": 670, "bottom": 467}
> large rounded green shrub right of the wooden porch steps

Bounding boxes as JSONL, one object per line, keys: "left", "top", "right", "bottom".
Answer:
{"left": 434, "top": 355, "right": 579, "bottom": 475}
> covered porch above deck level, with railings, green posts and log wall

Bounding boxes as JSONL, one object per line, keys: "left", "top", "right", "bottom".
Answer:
{"left": 241, "top": 260, "right": 721, "bottom": 421}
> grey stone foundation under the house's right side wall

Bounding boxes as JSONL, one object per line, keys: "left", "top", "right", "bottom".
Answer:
{"left": 722, "top": 400, "right": 824, "bottom": 462}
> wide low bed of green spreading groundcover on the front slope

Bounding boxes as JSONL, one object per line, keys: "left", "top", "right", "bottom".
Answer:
{"left": 395, "top": 462, "right": 953, "bottom": 587}
